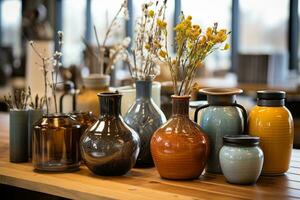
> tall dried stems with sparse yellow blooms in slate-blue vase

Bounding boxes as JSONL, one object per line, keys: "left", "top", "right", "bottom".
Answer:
{"left": 126, "top": 0, "right": 167, "bottom": 80}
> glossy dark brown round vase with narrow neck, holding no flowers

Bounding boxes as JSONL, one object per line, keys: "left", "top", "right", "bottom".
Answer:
{"left": 80, "top": 92, "right": 140, "bottom": 176}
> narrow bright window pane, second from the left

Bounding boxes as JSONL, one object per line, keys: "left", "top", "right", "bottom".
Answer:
{"left": 62, "top": 0, "right": 86, "bottom": 66}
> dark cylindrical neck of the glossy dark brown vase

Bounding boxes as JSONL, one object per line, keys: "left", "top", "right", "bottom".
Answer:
{"left": 98, "top": 92, "right": 122, "bottom": 116}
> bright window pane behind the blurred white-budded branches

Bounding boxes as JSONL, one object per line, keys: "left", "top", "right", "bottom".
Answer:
{"left": 91, "top": 0, "right": 125, "bottom": 45}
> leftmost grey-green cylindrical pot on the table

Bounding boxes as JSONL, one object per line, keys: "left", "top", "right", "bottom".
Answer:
{"left": 9, "top": 110, "right": 28, "bottom": 163}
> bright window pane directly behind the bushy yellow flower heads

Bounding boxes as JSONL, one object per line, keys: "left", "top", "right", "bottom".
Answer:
{"left": 181, "top": 0, "right": 232, "bottom": 70}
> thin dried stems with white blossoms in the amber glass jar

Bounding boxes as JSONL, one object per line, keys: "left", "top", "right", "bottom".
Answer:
{"left": 30, "top": 31, "right": 63, "bottom": 115}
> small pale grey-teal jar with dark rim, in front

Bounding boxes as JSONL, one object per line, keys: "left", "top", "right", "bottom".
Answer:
{"left": 219, "top": 135, "right": 264, "bottom": 184}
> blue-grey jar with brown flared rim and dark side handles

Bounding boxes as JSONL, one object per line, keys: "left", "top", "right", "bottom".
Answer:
{"left": 194, "top": 88, "right": 247, "bottom": 173}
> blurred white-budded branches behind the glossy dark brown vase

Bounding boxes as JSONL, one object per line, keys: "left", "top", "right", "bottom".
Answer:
{"left": 91, "top": 0, "right": 130, "bottom": 75}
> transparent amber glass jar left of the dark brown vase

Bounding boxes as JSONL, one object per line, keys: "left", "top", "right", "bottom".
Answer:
{"left": 32, "top": 114, "right": 80, "bottom": 171}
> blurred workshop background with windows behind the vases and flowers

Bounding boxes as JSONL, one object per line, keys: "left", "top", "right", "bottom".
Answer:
{"left": 0, "top": 0, "right": 300, "bottom": 145}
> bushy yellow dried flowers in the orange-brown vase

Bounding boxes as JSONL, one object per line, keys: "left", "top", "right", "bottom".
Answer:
{"left": 153, "top": 13, "right": 230, "bottom": 96}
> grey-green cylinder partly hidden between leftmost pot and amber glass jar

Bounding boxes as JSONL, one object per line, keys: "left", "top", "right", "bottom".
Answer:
{"left": 28, "top": 110, "right": 43, "bottom": 160}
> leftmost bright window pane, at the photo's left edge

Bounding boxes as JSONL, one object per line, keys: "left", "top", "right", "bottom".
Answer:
{"left": 1, "top": 0, "right": 22, "bottom": 56}
